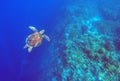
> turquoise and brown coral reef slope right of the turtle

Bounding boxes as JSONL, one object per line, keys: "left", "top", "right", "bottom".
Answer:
{"left": 38, "top": 0, "right": 120, "bottom": 81}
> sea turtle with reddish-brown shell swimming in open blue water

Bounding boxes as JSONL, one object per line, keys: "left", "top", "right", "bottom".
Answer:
{"left": 24, "top": 26, "right": 50, "bottom": 52}
